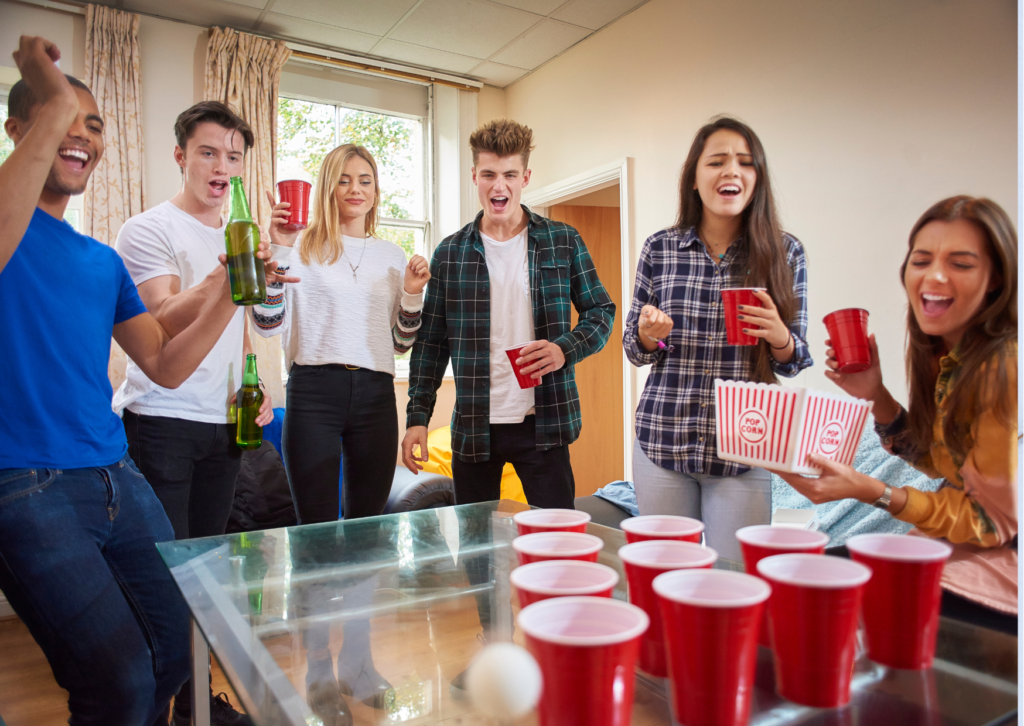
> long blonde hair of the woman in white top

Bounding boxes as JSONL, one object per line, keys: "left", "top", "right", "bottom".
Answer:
{"left": 299, "top": 143, "right": 381, "bottom": 264}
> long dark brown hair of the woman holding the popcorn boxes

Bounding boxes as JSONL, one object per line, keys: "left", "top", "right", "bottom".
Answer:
{"left": 899, "top": 196, "right": 1017, "bottom": 462}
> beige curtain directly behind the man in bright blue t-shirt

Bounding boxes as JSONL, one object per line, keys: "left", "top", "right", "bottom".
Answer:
{"left": 83, "top": 5, "right": 144, "bottom": 245}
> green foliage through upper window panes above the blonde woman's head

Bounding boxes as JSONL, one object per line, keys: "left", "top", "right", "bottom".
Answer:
{"left": 278, "top": 98, "right": 420, "bottom": 219}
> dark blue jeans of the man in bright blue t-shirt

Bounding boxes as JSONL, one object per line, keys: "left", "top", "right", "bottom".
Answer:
{"left": 0, "top": 456, "right": 189, "bottom": 726}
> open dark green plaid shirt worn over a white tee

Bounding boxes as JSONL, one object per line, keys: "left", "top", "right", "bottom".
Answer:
{"left": 407, "top": 207, "right": 615, "bottom": 462}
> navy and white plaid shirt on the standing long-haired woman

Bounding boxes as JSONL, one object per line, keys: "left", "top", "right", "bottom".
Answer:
{"left": 623, "top": 228, "right": 814, "bottom": 476}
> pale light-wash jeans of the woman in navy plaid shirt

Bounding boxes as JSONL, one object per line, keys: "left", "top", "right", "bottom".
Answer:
{"left": 633, "top": 441, "right": 771, "bottom": 562}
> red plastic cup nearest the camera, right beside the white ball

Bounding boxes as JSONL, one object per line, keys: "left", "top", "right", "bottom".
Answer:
{"left": 516, "top": 597, "right": 650, "bottom": 726}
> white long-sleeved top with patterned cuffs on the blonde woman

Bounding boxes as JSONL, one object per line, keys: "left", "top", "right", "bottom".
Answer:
{"left": 270, "top": 237, "right": 423, "bottom": 376}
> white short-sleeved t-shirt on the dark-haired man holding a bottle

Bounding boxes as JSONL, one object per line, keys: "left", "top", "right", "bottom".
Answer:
{"left": 114, "top": 202, "right": 245, "bottom": 424}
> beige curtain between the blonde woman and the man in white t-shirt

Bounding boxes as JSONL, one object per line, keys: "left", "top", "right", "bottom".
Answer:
{"left": 205, "top": 28, "right": 292, "bottom": 405}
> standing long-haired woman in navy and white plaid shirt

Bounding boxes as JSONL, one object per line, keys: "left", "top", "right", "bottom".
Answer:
{"left": 623, "top": 117, "right": 813, "bottom": 561}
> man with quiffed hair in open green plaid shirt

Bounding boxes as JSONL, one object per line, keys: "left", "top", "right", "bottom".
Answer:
{"left": 401, "top": 119, "right": 615, "bottom": 509}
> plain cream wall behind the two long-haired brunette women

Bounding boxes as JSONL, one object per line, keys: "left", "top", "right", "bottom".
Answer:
{"left": 501, "top": 0, "right": 1018, "bottom": 395}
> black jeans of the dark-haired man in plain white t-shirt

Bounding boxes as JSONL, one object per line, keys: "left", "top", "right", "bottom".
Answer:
{"left": 124, "top": 409, "right": 242, "bottom": 716}
